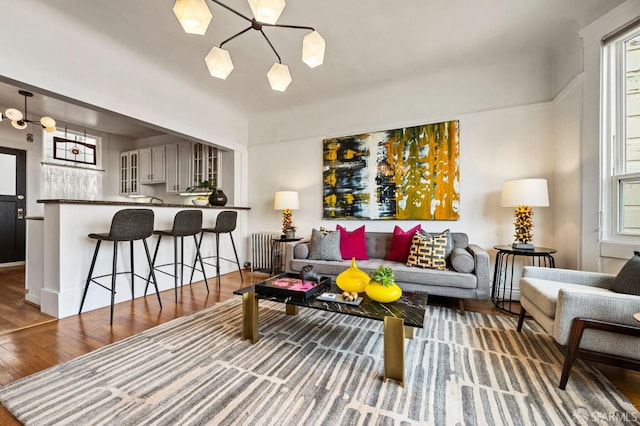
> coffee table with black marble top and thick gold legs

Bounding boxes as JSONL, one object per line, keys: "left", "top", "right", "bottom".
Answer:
{"left": 233, "top": 277, "right": 428, "bottom": 386}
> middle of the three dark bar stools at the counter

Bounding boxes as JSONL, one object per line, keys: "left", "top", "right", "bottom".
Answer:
{"left": 144, "top": 209, "right": 209, "bottom": 303}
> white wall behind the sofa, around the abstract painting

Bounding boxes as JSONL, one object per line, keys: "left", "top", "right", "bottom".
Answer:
{"left": 249, "top": 50, "right": 557, "bottom": 262}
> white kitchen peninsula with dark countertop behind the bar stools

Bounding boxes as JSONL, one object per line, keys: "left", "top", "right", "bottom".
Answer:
{"left": 25, "top": 199, "right": 249, "bottom": 318}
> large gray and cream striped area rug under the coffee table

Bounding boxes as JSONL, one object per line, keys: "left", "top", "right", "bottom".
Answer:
{"left": 0, "top": 298, "right": 640, "bottom": 425}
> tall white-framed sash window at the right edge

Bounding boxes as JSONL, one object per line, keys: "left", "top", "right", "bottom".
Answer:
{"left": 603, "top": 26, "right": 640, "bottom": 240}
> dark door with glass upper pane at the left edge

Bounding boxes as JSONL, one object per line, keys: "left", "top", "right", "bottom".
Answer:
{"left": 0, "top": 147, "right": 27, "bottom": 263}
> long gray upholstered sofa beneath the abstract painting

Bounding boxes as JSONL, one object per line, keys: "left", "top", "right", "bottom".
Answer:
{"left": 285, "top": 232, "right": 491, "bottom": 310}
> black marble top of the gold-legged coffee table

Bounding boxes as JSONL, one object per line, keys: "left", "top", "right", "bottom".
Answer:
{"left": 233, "top": 282, "right": 428, "bottom": 328}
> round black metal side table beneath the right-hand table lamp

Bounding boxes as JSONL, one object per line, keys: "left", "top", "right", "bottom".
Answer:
{"left": 491, "top": 246, "right": 557, "bottom": 315}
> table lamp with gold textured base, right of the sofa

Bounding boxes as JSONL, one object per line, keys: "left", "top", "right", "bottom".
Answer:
{"left": 500, "top": 179, "right": 549, "bottom": 250}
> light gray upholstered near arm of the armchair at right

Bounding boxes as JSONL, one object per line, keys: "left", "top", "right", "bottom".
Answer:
{"left": 554, "top": 288, "right": 640, "bottom": 345}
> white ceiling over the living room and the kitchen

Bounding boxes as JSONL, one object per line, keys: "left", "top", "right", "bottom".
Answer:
{"left": 0, "top": 0, "right": 622, "bottom": 138}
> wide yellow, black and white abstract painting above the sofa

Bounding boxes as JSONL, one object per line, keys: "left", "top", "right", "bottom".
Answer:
{"left": 322, "top": 120, "right": 460, "bottom": 220}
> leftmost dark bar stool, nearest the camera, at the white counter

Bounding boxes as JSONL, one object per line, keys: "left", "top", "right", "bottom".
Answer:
{"left": 78, "top": 209, "right": 162, "bottom": 325}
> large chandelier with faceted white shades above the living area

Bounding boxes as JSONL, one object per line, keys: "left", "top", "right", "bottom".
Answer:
{"left": 173, "top": 0, "right": 326, "bottom": 92}
